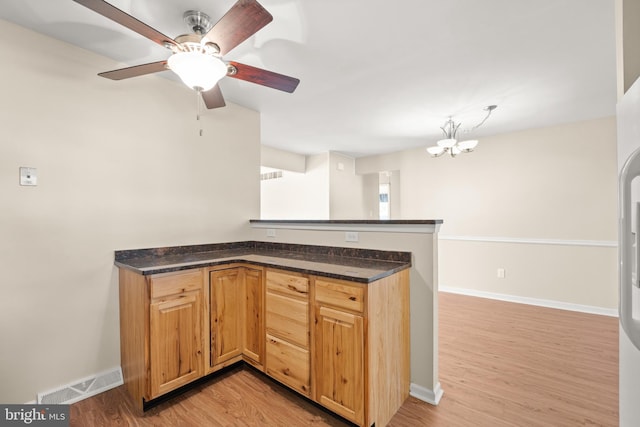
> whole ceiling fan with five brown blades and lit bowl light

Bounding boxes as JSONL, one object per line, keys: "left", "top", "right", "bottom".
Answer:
{"left": 73, "top": 0, "right": 300, "bottom": 109}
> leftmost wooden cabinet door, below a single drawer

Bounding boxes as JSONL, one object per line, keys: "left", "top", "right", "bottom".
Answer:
{"left": 149, "top": 292, "right": 203, "bottom": 398}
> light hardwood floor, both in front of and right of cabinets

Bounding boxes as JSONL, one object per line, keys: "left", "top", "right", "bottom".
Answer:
{"left": 71, "top": 293, "right": 618, "bottom": 427}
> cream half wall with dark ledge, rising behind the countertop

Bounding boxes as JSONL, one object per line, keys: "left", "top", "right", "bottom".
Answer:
{"left": 249, "top": 219, "right": 443, "bottom": 405}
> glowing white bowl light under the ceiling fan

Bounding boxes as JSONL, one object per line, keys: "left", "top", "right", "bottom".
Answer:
{"left": 167, "top": 51, "right": 227, "bottom": 92}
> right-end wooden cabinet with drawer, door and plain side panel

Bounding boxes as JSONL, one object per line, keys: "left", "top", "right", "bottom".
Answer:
{"left": 312, "top": 270, "right": 410, "bottom": 426}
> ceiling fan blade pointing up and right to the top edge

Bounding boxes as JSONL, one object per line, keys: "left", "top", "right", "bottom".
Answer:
{"left": 204, "top": 0, "right": 273, "bottom": 56}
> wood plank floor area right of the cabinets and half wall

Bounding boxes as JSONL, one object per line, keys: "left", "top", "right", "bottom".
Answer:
{"left": 404, "top": 293, "right": 618, "bottom": 427}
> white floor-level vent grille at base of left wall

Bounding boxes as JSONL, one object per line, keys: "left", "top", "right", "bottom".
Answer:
{"left": 38, "top": 367, "right": 123, "bottom": 405}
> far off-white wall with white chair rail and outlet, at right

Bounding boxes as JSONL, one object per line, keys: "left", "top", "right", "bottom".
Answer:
{"left": 356, "top": 117, "right": 617, "bottom": 309}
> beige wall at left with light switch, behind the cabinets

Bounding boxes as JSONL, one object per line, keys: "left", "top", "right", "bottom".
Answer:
{"left": 0, "top": 17, "right": 260, "bottom": 403}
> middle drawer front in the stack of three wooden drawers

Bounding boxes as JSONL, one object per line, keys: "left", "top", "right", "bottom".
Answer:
{"left": 267, "top": 292, "right": 309, "bottom": 348}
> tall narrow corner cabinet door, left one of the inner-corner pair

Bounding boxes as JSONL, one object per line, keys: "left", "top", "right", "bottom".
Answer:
{"left": 209, "top": 268, "right": 242, "bottom": 366}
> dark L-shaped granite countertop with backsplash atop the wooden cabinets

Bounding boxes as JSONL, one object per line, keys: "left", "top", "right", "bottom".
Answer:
{"left": 115, "top": 241, "right": 411, "bottom": 283}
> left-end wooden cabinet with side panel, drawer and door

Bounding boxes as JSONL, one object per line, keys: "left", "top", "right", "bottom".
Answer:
{"left": 120, "top": 270, "right": 204, "bottom": 409}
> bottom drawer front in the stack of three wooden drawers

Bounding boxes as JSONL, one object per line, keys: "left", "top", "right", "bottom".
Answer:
{"left": 267, "top": 335, "right": 311, "bottom": 396}
